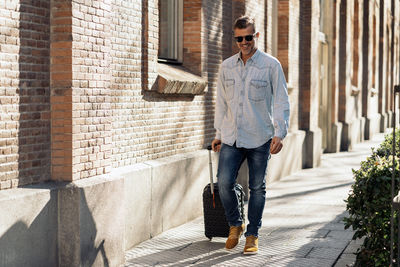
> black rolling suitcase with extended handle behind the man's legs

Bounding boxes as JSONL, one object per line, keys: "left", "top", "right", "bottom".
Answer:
{"left": 203, "top": 146, "right": 245, "bottom": 240}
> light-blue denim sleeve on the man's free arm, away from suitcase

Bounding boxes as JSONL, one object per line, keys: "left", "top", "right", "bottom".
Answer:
{"left": 271, "top": 63, "right": 290, "bottom": 139}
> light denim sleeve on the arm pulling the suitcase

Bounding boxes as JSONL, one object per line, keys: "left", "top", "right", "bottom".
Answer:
{"left": 214, "top": 66, "right": 227, "bottom": 140}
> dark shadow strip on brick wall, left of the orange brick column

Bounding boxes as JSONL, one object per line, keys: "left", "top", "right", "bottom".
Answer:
{"left": 17, "top": 0, "right": 50, "bottom": 187}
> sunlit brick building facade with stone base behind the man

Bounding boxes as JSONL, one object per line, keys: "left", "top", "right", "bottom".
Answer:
{"left": 0, "top": 0, "right": 400, "bottom": 266}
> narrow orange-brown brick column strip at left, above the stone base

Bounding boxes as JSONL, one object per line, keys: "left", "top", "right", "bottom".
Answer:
{"left": 50, "top": 0, "right": 72, "bottom": 181}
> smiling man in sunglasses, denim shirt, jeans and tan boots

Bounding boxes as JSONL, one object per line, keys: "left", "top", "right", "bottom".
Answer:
{"left": 212, "top": 16, "right": 289, "bottom": 254}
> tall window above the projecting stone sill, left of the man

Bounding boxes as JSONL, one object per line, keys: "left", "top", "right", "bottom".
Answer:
{"left": 158, "top": 0, "right": 183, "bottom": 63}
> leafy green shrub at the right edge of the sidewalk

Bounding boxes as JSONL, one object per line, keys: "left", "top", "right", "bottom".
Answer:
{"left": 344, "top": 131, "right": 400, "bottom": 266}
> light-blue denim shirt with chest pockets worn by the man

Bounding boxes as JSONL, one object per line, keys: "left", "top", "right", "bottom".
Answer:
{"left": 214, "top": 49, "right": 290, "bottom": 148}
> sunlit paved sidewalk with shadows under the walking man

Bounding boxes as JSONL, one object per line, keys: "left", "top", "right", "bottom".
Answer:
{"left": 125, "top": 134, "right": 384, "bottom": 267}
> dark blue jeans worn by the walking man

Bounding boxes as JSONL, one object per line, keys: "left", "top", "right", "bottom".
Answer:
{"left": 217, "top": 140, "right": 271, "bottom": 236}
